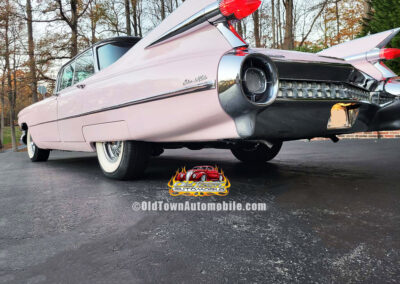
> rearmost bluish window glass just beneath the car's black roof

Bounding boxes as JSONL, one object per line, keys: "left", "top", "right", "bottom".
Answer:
{"left": 97, "top": 43, "right": 133, "bottom": 70}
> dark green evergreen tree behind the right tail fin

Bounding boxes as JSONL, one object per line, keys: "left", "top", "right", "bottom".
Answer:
{"left": 362, "top": 0, "right": 400, "bottom": 74}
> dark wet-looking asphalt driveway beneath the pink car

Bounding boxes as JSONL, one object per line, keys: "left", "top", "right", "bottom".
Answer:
{"left": 0, "top": 140, "right": 400, "bottom": 283}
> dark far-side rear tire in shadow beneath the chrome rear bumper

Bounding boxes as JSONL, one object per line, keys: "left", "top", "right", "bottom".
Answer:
{"left": 231, "top": 142, "right": 282, "bottom": 163}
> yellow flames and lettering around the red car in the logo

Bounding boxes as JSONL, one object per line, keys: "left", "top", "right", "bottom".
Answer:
{"left": 168, "top": 166, "right": 231, "bottom": 197}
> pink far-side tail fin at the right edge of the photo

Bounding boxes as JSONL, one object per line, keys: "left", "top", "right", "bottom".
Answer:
{"left": 318, "top": 28, "right": 400, "bottom": 80}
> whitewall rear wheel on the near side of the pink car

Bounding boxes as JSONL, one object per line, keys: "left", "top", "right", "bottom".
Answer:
{"left": 96, "top": 141, "right": 150, "bottom": 180}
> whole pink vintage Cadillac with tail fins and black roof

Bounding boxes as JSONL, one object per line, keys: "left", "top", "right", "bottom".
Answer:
{"left": 19, "top": 0, "right": 400, "bottom": 179}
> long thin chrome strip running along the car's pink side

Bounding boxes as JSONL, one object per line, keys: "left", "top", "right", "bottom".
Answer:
{"left": 31, "top": 81, "right": 216, "bottom": 127}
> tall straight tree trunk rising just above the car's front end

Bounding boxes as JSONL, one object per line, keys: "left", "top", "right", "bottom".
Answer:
{"left": 26, "top": 0, "right": 38, "bottom": 103}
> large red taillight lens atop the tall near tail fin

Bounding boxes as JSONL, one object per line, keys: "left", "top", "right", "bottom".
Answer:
{"left": 219, "top": 0, "right": 262, "bottom": 20}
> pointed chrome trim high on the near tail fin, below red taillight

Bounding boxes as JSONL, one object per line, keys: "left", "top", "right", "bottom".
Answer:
{"left": 146, "top": 1, "right": 222, "bottom": 48}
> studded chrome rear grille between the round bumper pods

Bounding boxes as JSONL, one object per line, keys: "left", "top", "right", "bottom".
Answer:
{"left": 278, "top": 81, "right": 372, "bottom": 102}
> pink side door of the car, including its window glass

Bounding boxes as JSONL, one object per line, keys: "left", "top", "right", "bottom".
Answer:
{"left": 58, "top": 49, "right": 95, "bottom": 142}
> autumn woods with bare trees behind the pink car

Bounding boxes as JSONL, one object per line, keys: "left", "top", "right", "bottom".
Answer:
{"left": 0, "top": 0, "right": 400, "bottom": 149}
